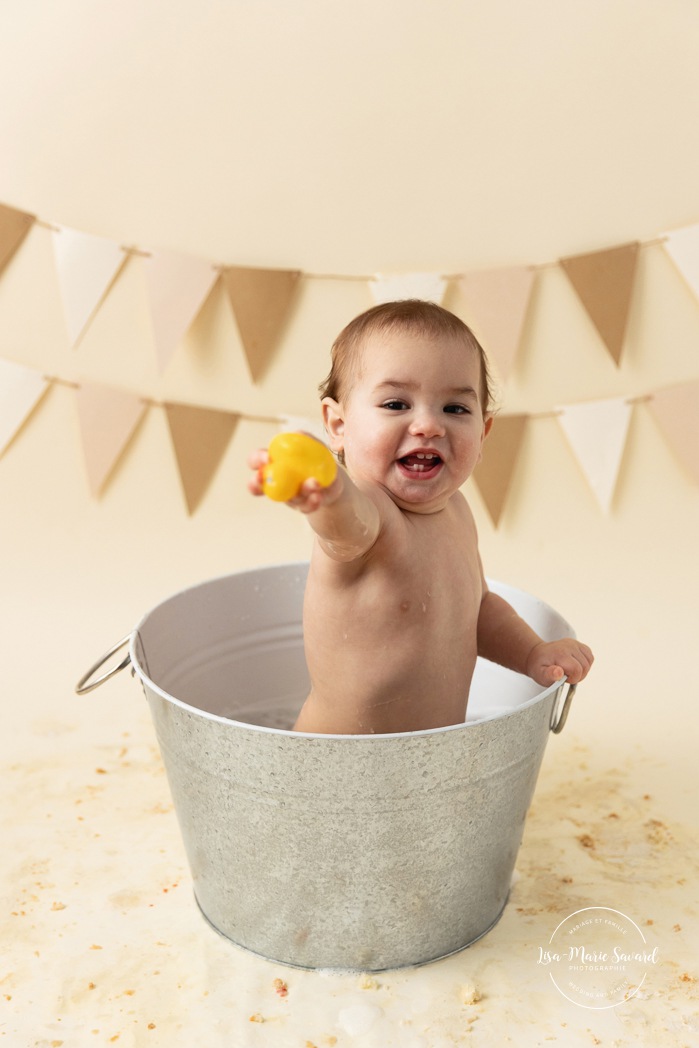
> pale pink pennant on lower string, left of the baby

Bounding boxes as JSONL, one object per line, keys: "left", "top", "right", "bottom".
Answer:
{"left": 75, "top": 383, "right": 146, "bottom": 496}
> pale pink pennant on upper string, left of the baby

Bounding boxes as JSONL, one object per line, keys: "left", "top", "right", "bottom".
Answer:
{"left": 146, "top": 252, "right": 218, "bottom": 371}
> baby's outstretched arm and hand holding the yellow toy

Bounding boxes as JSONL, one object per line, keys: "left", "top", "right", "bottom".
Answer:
{"left": 247, "top": 449, "right": 380, "bottom": 561}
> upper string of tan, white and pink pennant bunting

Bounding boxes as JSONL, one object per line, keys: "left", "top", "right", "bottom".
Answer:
{"left": 0, "top": 198, "right": 699, "bottom": 381}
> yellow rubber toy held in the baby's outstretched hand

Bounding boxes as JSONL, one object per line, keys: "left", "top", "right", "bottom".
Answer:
{"left": 260, "top": 433, "right": 337, "bottom": 502}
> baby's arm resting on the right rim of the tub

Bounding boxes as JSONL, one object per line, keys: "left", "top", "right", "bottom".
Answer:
{"left": 478, "top": 588, "right": 593, "bottom": 687}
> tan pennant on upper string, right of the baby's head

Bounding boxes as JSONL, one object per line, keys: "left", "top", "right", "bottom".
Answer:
{"left": 560, "top": 242, "right": 640, "bottom": 364}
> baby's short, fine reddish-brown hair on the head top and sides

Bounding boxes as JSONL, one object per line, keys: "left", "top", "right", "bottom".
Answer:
{"left": 319, "top": 299, "right": 494, "bottom": 417}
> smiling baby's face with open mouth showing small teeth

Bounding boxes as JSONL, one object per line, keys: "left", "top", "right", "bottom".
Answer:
{"left": 324, "top": 322, "right": 489, "bottom": 512}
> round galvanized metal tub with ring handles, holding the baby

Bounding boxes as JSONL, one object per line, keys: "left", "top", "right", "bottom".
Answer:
{"left": 78, "top": 563, "right": 574, "bottom": 970}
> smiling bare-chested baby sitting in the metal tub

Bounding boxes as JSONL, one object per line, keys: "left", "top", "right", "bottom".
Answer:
{"left": 248, "top": 301, "right": 592, "bottom": 735}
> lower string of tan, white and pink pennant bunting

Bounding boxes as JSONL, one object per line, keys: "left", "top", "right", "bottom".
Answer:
{"left": 0, "top": 358, "right": 699, "bottom": 519}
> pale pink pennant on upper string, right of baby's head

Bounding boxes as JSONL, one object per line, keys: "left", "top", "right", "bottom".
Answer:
{"left": 459, "top": 266, "right": 536, "bottom": 379}
